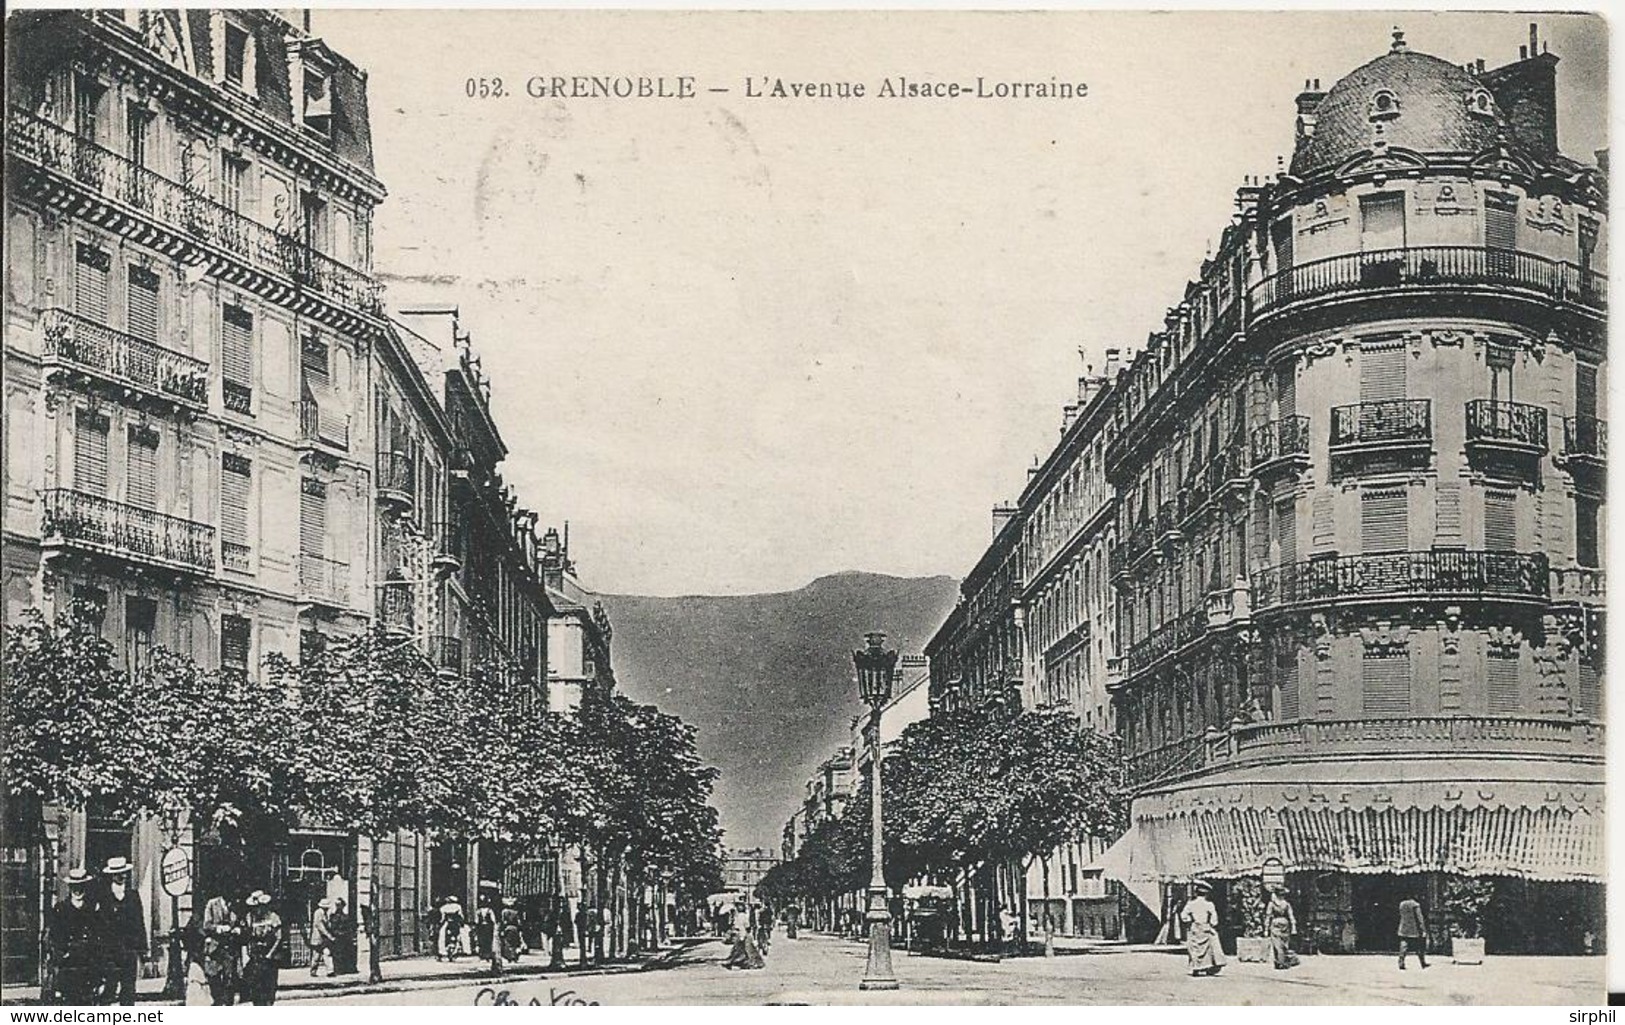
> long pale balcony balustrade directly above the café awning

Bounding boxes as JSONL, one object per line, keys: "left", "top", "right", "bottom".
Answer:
{"left": 1126, "top": 715, "right": 1607, "bottom": 786}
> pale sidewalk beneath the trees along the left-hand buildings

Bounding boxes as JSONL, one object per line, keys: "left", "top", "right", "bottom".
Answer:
{"left": 0, "top": 937, "right": 705, "bottom": 1006}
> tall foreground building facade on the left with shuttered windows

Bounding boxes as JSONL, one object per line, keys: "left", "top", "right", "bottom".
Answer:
{"left": 3, "top": 10, "right": 384, "bottom": 978}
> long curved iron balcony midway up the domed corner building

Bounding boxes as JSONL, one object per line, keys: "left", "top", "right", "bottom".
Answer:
{"left": 1253, "top": 547, "right": 1552, "bottom": 612}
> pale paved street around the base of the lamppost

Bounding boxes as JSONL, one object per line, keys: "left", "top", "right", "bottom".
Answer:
{"left": 299, "top": 932, "right": 1604, "bottom": 1006}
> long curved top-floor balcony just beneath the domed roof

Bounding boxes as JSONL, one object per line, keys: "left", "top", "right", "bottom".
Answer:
{"left": 1248, "top": 245, "right": 1607, "bottom": 323}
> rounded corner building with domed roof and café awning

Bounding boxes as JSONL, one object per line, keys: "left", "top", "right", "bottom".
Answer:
{"left": 1103, "top": 31, "right": 1607, "bottom": 954}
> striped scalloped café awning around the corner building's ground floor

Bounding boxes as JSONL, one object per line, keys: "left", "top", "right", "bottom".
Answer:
{"left": 1131, "top": 786, "right": 1606, "bottom": 882}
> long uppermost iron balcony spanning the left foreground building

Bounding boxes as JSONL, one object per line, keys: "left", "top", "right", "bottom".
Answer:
{"left": 7, "top": 107, "right": 382, "bottom": 315}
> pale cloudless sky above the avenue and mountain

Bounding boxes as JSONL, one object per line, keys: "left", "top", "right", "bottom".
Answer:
{"left": 312, "top": 10, "right": 1607, "bottom": 595}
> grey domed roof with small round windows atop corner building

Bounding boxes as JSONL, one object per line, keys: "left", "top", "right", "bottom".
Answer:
{"left": 1292, "top": 42, "right": 1515, "bottom": 175}
